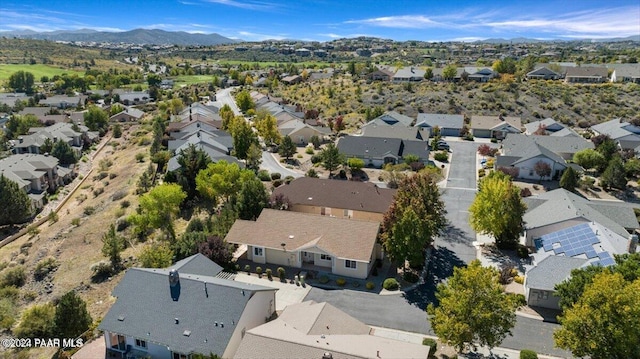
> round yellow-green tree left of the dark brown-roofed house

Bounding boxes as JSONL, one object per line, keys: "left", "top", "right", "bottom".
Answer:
{"left": 196, "top": 160, "right": 255, "bottom": 203}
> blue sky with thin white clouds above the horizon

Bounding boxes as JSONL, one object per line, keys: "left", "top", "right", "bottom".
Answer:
{"left": 0, "top": 0, "right": 640, "bottom": 41}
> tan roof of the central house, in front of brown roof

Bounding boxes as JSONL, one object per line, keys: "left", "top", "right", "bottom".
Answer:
{"left": 225, "top": 209, "right": 380, "bottom": 262}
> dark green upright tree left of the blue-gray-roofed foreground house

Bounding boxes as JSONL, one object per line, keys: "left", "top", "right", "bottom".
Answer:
{"left": 53, "top": 290, "right": 93, "bottom": 338}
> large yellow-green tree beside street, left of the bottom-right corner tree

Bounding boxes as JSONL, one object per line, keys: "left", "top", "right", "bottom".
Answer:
{"left": 427, "top": 260, "right": 519, "bottom": 351}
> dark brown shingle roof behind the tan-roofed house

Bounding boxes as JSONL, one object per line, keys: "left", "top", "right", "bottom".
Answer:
{"left": 273, "top": 177, "right": 396, "bottom": 213}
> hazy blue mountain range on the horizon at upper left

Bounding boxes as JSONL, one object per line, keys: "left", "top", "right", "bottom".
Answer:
{"left": 0, "top": 29, "right": 239, "bottom": 46}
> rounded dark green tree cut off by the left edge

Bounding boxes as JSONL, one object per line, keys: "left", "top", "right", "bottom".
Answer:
{"left": 0, "top": 173, "right": 33, "bottom": 226}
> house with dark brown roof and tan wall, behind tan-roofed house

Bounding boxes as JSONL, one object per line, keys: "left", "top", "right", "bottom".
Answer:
{"left": 273, "top": 177, "right": 396, "bottom": 222}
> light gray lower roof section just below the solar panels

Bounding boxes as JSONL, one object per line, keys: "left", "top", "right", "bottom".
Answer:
{"left": 527, "top": 256, "right": 587, "bottom": 291}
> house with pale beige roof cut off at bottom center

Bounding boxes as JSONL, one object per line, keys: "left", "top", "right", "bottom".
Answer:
{"left": 234, "top": 301, "right": 430, "bottom": 359}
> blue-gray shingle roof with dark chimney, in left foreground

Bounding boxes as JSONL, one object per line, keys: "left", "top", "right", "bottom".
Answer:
{"left": 99, "top": 256, "right": 276, "bottom": 355}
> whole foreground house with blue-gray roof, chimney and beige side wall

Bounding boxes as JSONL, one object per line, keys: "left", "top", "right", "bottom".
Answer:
{"left": 98, "top": 254, "right": 277, "bottom": 359}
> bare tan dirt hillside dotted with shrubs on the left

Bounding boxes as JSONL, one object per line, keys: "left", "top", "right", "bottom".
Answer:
{"left": 0, "top": 126, "right": 149, "bottom": 346}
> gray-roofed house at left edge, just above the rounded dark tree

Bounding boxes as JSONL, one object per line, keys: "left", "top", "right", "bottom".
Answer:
{"left": 0, "top": 154, "right": 65, "bottom": 210}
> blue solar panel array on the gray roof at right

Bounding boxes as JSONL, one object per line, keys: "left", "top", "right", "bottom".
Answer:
{"left": 539, "top": 223, "right": 600, "bottom": 259}
